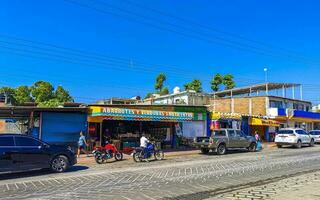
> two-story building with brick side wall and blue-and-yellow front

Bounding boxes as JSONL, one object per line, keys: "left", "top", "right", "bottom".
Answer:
{"left": 209, "top": 83, "right": 320, "bottom": 141}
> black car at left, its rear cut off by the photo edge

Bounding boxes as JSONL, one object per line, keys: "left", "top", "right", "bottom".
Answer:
{"left": 0, "top": 134, "right": 77, "bottom": 174}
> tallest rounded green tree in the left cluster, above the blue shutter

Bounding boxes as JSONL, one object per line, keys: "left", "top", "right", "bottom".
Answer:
{"left": 31, "top": 81, "right": 54, "bottom": 103}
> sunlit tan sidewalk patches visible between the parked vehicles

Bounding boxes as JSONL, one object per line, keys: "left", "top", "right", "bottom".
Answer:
{"left": 78, "top": 142, "right": 276, "bottom": 165}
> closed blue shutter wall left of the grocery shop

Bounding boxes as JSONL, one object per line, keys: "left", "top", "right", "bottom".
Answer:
{"left": 41, "top": 112, "right": 87, "bottom": 145}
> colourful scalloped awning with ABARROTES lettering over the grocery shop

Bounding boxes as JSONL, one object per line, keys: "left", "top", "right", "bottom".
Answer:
{"left": 88, "top": 106, "right": 196, "bottom": 122}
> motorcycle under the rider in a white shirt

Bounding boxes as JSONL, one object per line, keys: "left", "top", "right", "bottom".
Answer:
{"left": 132, "top": 143, "right": 164, "bottom": 162}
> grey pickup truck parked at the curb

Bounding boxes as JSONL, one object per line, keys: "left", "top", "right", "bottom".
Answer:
{"left": 194, "top": 129, "right": 257, "bottom": 155}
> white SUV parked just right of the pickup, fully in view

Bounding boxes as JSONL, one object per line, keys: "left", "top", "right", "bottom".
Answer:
{"left": 275, "top": 128, "right": 315, "bottom": 148}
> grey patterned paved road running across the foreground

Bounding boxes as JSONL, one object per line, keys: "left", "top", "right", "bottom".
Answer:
{"left": 0, "top": 146, "right": 320, "bottom": 200}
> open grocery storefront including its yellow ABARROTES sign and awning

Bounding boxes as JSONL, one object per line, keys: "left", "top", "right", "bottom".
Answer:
{"left": 88, "top": 106, "right": 206, "bottom": 150}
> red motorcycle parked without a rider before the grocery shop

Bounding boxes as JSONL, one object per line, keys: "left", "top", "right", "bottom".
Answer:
{"left": 92, "top": 144, "right": 123, "bottom": 164}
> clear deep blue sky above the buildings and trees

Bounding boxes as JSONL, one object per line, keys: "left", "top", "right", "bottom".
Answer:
{"left": 0, "top": 0, "right": 320, "bottom": 103}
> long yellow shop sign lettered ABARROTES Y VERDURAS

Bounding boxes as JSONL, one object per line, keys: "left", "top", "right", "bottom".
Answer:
{"left": 91, "top": 106, "right": 196, "bottom": 121}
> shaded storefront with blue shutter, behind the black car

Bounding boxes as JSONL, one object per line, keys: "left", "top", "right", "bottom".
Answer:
{"left": 0, "top": 107, "right": 88, "bottom": 147}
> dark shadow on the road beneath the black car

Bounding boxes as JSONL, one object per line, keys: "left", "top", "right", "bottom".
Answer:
{"left": 0, "top": 165, "right": 89, "bottom": 180}
